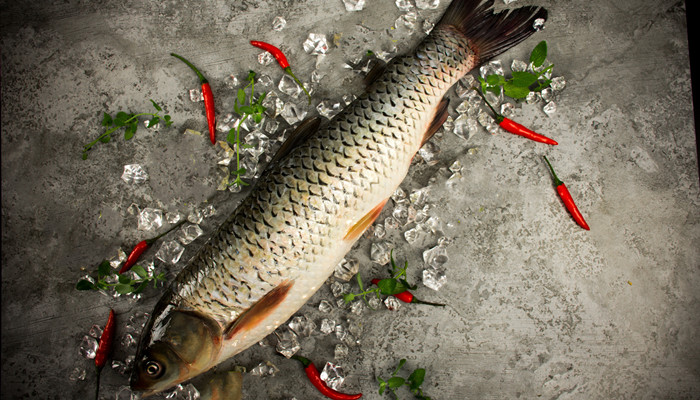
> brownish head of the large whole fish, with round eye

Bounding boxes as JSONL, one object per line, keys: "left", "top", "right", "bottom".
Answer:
{"left": 131, "top": 310, "right": 221, "bottom": 397}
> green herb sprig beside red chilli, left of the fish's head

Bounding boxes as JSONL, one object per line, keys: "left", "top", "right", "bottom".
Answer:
{"left": 75, "top": 260, "right": 165, "bottom": 294}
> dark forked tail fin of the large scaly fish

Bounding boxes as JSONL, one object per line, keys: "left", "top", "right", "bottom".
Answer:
{"left": 435, "top": 0, "right": 547, "bottom": 64}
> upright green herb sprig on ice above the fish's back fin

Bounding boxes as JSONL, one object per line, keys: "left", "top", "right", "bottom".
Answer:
{"left": 226, "top": 71, "right": 267, "bottom": 186}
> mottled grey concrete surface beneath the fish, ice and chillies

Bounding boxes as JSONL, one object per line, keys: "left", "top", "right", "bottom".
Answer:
{"left": 0, "top": 0, "right": 700, "bottom": 400}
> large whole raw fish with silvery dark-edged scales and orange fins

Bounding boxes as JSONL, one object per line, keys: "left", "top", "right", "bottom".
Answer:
{"left": 130, "top": 0, "right": 547, "bottom": 396}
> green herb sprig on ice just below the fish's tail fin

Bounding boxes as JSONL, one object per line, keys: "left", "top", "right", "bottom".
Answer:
{"left": 478, "top": 40, "right": 554, "bottom": 99}
